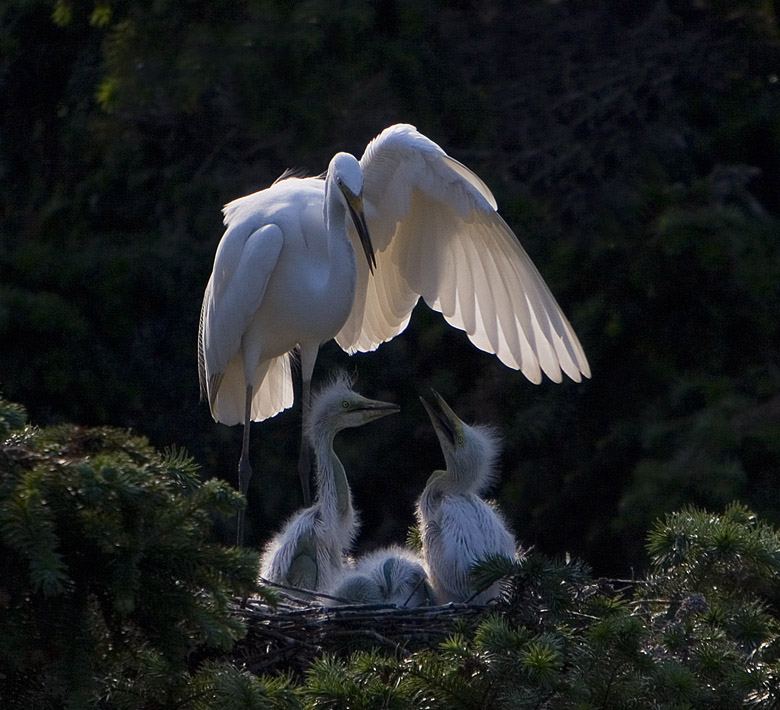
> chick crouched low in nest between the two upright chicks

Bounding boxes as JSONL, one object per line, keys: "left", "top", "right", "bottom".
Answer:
{"left": 328, "top": 545, "right": 433, "bottom": 608}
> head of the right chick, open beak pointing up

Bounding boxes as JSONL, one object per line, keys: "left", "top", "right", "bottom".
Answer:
{"left": 420, "top": 390, "right": 499, "bottom": 493}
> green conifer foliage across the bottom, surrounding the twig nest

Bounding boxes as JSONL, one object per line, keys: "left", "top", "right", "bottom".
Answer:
{"left": 0, "top": 400, "right": 780, "bottom": 710}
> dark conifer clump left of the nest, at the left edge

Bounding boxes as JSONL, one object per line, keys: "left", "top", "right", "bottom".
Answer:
{"left": 0, "top": 401, "right": 258, "bottom": 709}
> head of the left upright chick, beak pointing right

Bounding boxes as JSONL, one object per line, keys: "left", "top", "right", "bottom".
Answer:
{"left": 307, "top": 373, "right": 400, "bottom": 444}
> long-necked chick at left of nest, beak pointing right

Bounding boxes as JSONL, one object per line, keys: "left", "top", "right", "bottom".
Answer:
{"left": 260, "top": 374, "right": 398, "bottom": 591}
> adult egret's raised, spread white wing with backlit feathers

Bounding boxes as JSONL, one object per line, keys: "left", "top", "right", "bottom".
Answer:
{"left": 336, "top": 124, "right": 590, "bottom": 383}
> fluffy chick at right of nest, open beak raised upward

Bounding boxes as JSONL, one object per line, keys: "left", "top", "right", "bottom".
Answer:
{"left": 417, "top": 391, "right": 515, "bottom": 604}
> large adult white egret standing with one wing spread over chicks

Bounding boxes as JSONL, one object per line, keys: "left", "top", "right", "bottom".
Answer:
{"left": 198, "top": 124, "right": 590, "bottom": 537}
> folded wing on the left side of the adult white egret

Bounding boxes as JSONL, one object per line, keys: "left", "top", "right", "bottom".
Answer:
{"left": 198, "top": 223, "right": 289, "bottom": 424}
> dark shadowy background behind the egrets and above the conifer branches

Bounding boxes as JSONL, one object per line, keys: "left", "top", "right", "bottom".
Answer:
{"left": 0, "top": 0, "right": 780, "bottom": 574}
